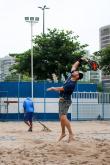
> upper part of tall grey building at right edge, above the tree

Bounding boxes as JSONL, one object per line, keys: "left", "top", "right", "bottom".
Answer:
{"left": 99, "top": 25, "right": 110, "bottom": 49}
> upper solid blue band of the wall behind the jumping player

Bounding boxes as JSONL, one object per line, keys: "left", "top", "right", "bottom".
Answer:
{"left": 0, "top": 81, "right": 97, "bottom": 98}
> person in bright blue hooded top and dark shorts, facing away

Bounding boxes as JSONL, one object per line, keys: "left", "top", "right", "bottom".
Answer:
{"left": 23, "top": 97, "right": 34, "bottom": 132}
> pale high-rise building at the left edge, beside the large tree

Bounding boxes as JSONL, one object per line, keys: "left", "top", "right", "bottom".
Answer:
{"left": 0, "top": 56, "right": 15, "bottom": 81}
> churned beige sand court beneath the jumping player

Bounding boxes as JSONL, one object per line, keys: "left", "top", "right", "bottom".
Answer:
{"left": 0, "top": 121, "right": 110, "bottom": 165}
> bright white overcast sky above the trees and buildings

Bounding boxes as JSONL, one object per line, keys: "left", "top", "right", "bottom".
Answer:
{"left": 0, "top": 0, "right": 110, "bottom": 58}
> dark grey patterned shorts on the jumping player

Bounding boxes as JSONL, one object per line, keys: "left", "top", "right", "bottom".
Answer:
{"left": 59, "top": 100, "right": 72, "bottom": 116}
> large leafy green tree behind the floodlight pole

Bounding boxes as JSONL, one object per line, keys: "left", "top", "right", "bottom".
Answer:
{"left": 11, "top": 29, "right": 87, "bottom": 80}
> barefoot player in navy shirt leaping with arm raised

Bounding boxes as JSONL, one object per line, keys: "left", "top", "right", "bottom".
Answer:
{"left": 47, "top": 57, "right": 84, "bottom": 142}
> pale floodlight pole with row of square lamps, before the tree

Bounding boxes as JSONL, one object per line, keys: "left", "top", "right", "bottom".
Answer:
{"left": 25, "top": 17, "right": 39, "bottom": 99}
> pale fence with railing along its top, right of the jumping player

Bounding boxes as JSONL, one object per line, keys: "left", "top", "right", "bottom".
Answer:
{"left": 71, "top": 92, "right": 110, "bottom": 120}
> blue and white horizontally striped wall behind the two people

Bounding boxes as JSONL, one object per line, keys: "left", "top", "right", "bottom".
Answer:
{"left": 0, "top": 81, "right": 97, "bottom": 121}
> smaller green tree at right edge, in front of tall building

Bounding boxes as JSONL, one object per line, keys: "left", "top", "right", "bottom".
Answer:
{"left": 94, "top": 46, "right": 110, "bottom": 75}
